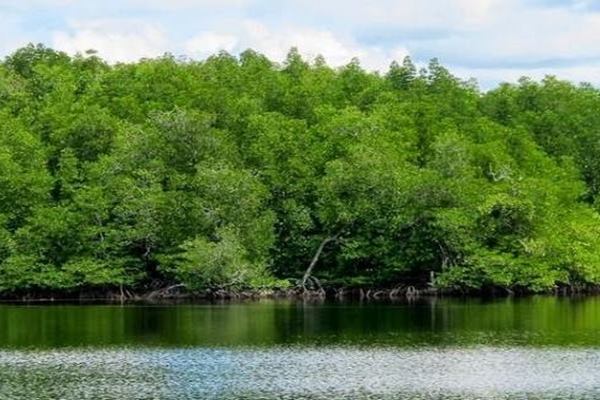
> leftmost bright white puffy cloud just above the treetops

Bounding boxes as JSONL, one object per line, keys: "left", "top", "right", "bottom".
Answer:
{"left": 52, "top": 19, "right": 170, "bottom": 62}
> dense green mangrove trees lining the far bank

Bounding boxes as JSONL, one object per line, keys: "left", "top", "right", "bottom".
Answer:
{"left": 0, "top": 45, "right": 600, "bottom": 294}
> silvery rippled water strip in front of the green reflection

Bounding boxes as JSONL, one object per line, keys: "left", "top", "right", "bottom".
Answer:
{"left": 0, "top": 346, "right": 600, "bottom": 400}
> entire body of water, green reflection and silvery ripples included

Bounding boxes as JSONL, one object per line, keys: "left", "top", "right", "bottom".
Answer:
{"left": 0, "top": 297, "right": 600, "bottom": 400}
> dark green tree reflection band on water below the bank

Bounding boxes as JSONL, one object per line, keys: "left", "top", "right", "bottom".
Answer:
{"left": 0, "top": 297, "right": 600, "bottom": 348}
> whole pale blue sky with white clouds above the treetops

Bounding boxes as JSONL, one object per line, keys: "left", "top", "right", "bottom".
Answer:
{"left": 0, "top": 0, "right": 600, "bottom": 89}
